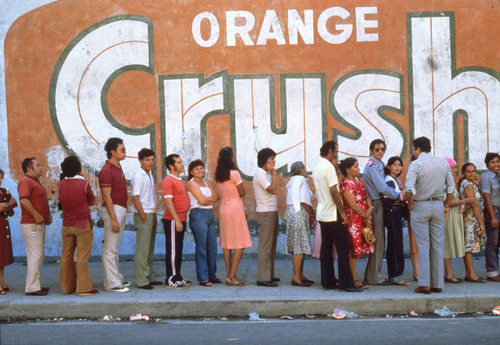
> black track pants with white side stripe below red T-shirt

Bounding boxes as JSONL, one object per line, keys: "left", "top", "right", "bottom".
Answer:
{"left": 162, "top": 219, "right": 186, "bottom": 282}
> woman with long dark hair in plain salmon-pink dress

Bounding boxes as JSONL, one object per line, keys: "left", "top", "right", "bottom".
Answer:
{"left": 215, "top": 147, "right": 252, "bottom": 286}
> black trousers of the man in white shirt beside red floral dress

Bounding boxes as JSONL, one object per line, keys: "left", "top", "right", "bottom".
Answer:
{"left": 319, "top": 221, "right": 354, "bottom": 290}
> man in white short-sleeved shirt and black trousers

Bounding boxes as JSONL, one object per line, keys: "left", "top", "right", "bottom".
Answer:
{"left": 313, "top": 141, "right": 363, "bottom": 292}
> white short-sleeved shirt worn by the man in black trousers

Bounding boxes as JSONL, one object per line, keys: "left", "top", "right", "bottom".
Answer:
{"left": 313, "top": 157, "right": 338, "bottom": 222}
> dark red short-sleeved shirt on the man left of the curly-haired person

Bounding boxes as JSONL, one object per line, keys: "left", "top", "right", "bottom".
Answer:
{"left": 17, "top": 175, "right": 50, "bottom": 224}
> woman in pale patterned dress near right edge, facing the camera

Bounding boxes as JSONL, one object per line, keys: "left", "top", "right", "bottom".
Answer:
{"left": 458, "top": 162, "right": 486, "bottom": 283}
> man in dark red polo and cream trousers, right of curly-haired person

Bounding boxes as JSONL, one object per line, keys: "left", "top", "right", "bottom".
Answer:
{"left": 99, "top": 138, "right": 130, "bottom": 292}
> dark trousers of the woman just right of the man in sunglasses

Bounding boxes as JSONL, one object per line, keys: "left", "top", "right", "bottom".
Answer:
{"left": 384, "top": 206, "right": 405, "bottom": 283}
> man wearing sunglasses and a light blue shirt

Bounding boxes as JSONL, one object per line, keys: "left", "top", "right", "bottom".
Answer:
{"left": 363, "top": 139, "right": 399, "bottom": 285}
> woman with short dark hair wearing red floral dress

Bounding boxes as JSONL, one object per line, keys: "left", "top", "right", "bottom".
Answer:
{"left": 339, "top": 157, "right": 375, "bottom": 289}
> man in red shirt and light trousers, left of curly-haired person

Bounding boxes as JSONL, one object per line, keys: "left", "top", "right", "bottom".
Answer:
{"left": 17, "top": 157, "right": 52, "bottom": 296}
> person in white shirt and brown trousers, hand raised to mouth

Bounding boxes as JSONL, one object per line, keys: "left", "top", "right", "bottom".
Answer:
{"left": 253, "top": 148, "right": 279, "bottom": 287}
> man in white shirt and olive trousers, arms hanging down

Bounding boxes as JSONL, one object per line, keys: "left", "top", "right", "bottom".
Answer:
{"left": 132, "top": 149, "right": 162, "bottom": 290}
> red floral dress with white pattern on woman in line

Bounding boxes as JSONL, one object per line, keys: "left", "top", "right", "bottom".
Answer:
{"left": 340, "top": 177, "right": 375, "bottom": 258}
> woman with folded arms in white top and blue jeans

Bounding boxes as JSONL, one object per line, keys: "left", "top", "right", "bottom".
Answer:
{"left": 187, "top": 159, "right": 222, "bottom": 287}
